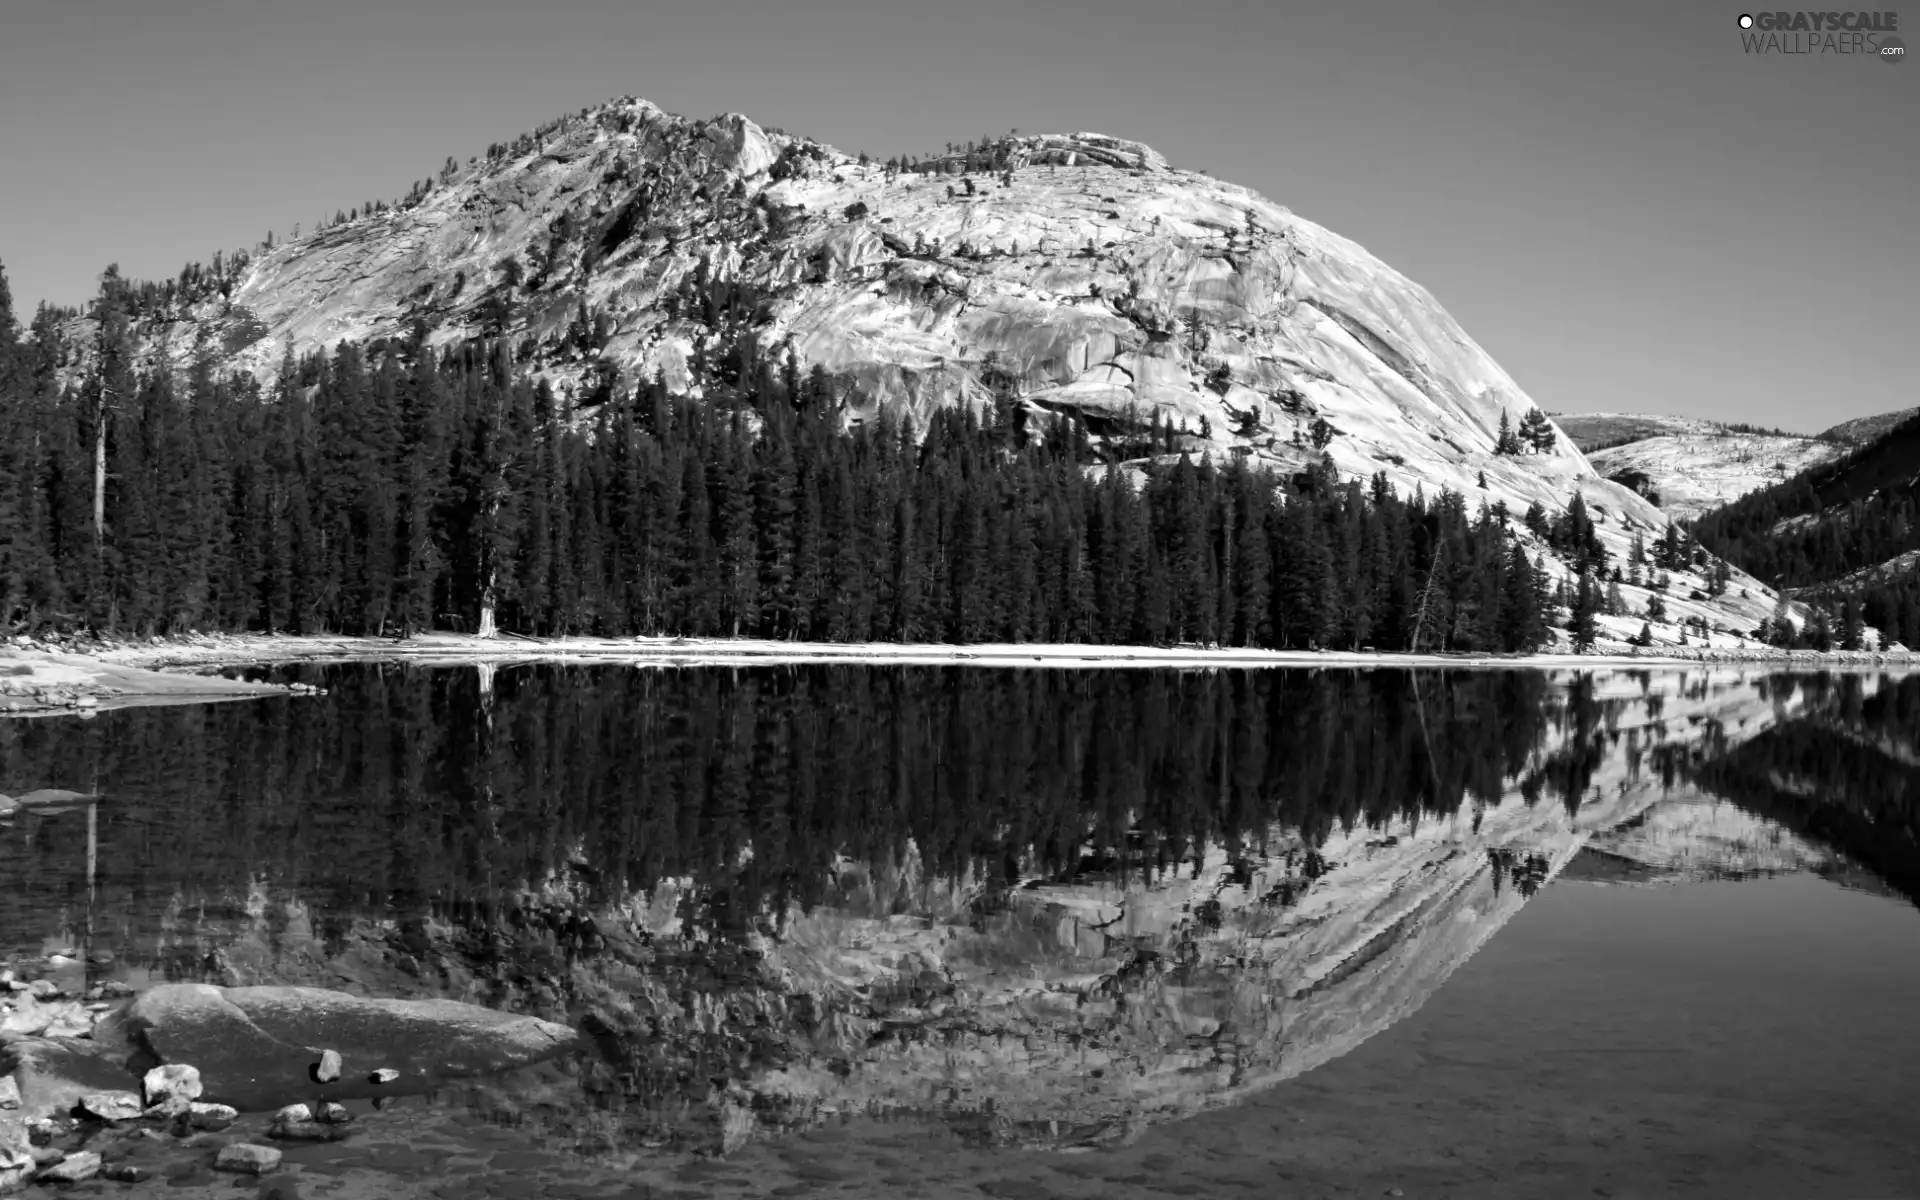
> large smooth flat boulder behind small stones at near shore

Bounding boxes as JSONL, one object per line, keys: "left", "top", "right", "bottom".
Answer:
{"left": 127, "top": 985, "right": 584, "bottom": 1108}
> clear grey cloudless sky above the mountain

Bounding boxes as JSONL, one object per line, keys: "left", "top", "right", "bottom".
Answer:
{"left": 0, "top": 0, "right": 1920, "bottom": 430}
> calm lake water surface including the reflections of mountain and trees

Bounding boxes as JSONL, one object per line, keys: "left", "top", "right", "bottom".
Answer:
{"left": 0, "top": 664, "right": 1920, "bottom": 1200}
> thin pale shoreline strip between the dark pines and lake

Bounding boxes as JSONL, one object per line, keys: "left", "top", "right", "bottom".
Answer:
{"left": 0, "top": 634, "right": 1920, "bottom": 683}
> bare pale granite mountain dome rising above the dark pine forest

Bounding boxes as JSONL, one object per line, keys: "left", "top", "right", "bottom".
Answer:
{"left": 56, "top": 100, "right": 1772, "bottom": 626}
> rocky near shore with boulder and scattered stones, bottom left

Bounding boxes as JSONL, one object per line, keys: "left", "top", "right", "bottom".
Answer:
{"left": 0, "top": 967, "right": 584, "bottom": 1200}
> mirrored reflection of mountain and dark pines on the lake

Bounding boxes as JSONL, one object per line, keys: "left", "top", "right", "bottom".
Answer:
{"left": 0, "top": 664, "right": 1920, "bottom": 1144}
